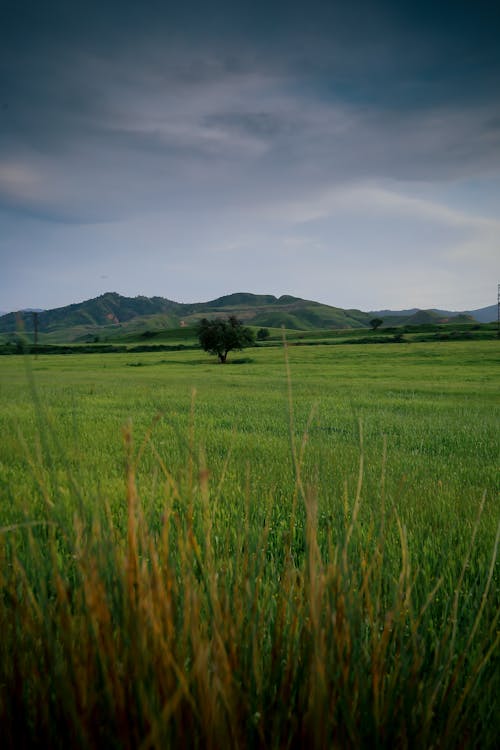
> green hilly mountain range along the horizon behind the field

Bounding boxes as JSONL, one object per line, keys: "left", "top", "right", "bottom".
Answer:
{"left": 0, "top": 292, "right": 497, "bottom": 342}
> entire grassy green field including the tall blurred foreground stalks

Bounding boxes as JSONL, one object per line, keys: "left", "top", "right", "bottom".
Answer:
{"left": 0, "top": 340, "right": 500, "bottom": 748}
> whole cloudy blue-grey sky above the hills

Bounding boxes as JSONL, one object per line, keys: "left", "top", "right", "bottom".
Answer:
{"left": 0, "top": 0, "right": 500, "bottom": 311}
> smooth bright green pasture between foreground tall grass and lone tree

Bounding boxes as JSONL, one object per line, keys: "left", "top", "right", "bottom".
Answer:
{"left": 0, "top": 342, "right": 499, "bottom": 541}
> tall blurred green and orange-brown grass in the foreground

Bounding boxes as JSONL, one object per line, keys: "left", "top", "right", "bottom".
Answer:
{"left": 0, "top": 362, "right": 500, "bottom": 748}
